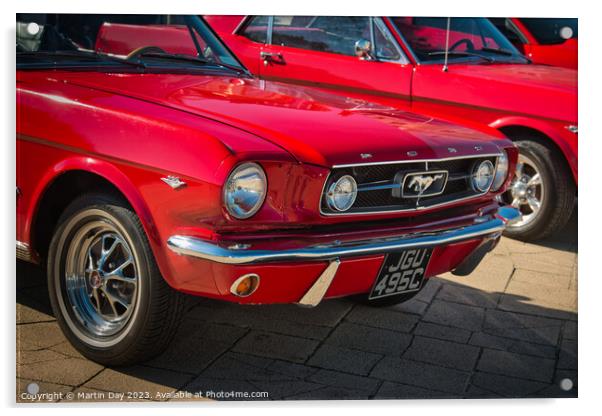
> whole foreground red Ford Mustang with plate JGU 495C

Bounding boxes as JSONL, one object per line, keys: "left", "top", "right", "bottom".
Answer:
{"left": 16, "top": 15, "right": 520, "bottom": 364}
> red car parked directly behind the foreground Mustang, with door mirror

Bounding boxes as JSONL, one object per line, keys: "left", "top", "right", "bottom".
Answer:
{"left": 207, "top": 16, "right": 578, "bottom": 240}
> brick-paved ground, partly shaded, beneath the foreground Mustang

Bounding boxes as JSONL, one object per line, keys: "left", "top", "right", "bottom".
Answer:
{"left": 17, "top": 215, "right": 577, "bottom": 401}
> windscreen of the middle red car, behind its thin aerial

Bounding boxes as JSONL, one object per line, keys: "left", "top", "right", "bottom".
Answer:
{"left": 391, "top": 17, "right": 528, "bottom": 62}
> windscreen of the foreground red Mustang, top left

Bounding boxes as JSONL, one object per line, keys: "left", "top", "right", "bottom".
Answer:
{"left": 16, "top": 14, "right": 244, "bottom": 71}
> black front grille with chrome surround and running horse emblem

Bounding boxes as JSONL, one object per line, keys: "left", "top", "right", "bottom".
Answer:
{"left": 321, "top": 155, "right": 497, "bottom": 215}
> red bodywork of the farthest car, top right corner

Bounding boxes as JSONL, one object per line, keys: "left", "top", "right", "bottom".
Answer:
{"left": 510, "top": 17, "right": 579, "bottom": 69}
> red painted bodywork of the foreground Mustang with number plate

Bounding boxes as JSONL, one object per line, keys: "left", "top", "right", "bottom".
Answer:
{"left": 17, "top": 48, "right": 516, "bottom": 303}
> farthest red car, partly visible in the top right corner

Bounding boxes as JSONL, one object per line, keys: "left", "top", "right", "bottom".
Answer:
{"left": 489, "top": 17, "right": 578, "bottom": 69}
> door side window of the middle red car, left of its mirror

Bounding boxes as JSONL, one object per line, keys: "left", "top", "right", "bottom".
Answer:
{"left": 272, "top": 16, "right": 370, "bottom": 56}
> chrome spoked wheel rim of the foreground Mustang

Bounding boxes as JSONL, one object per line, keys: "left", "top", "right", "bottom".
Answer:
{"left": 54, "top": 209, "right": 143, "bottom": 348}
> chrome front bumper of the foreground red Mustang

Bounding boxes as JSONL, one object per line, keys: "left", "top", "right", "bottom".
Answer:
{"left": 167, "top": 207, "right": 521, "bottom": 264}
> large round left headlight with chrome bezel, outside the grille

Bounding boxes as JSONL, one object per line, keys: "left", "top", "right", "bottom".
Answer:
{"left": 222, "top": 162, "right": 268, "bottom": 220}
